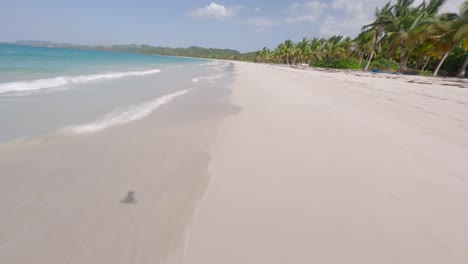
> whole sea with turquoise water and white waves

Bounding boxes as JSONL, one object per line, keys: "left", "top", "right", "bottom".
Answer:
{"left": 0, "top": 45, "right": 233, "bottom": 143}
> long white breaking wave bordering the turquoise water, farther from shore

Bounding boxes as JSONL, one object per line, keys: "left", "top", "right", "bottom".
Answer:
{"left": 0, "top": 69, "right": 161, "bottom": 94}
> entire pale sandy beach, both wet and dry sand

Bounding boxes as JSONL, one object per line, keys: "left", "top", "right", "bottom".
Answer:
{"left": 0, "top": 62, "right": 468, "bottom": 264}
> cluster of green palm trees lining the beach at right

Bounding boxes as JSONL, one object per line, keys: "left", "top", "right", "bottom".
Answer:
{"left": 255, "top": 0, "right": 468, "bottom": 77}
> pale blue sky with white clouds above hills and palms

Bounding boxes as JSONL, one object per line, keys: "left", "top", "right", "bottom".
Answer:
{"left": 0, "top": 0, "right": 463, "bottom": 52}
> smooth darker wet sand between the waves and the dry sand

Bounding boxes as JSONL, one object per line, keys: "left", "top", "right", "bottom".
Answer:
{"left": 0, "top": 84, "right": 238, "bottom": 264}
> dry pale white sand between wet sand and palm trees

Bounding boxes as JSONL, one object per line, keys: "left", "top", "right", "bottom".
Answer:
{"left": 185, "top": 63, "right": 468, "bottom": 264}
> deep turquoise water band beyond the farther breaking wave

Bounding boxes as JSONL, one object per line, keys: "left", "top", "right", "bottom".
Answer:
{"left": 0, "top": 45, "right": 202, "bottom": 83}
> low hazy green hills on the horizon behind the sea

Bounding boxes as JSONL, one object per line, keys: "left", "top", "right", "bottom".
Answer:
{"left": 4, "top": 40, "right": 250, "bottom": 60}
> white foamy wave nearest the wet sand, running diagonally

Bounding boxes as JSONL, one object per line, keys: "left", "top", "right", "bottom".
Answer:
{"left": 67, "top": 89, "right": 192, "bottom": 134}
